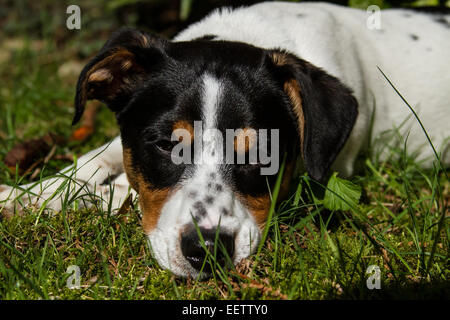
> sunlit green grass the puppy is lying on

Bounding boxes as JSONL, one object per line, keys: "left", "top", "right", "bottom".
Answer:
{"left": 0, "top": 37, "right": 450, "bottom": 299}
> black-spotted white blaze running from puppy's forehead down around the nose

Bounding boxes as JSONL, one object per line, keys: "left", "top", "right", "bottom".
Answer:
{"left": 149, "top": 74, "right": 259, "bottom": 277}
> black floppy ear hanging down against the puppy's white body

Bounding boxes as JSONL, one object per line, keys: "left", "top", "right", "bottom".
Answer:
{"left": 268, "top": 50, "right": 358, "bottom": 181}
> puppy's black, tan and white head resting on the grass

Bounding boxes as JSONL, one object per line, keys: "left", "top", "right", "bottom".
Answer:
{"left": 74, "top": 29, "right": 357, "bottom": 277}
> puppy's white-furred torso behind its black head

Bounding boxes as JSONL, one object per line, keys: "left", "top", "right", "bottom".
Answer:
{"left": 175, "top": 2, "right": 450, "bottom": 176}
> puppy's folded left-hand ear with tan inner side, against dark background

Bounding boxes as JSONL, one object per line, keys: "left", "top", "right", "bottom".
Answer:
{"left": 72, "top": 28, "right": 168, "bottom": 124}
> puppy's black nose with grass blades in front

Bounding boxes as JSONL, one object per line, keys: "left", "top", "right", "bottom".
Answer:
{"left": 181, "top": 228, "right": 234, "bottom": 273}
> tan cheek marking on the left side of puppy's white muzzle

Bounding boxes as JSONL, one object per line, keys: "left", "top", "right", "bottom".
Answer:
{"left": 123, "top": 148, "right": 170, "bottom": 234}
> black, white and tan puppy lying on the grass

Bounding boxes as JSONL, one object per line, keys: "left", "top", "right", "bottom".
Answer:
{"left": 0, "top": 2, "right": 450, "bottom": 277}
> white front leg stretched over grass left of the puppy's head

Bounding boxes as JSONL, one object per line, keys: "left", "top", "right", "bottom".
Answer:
{"left": 0, "top": 137, "right": 133, "bottom": 215}
